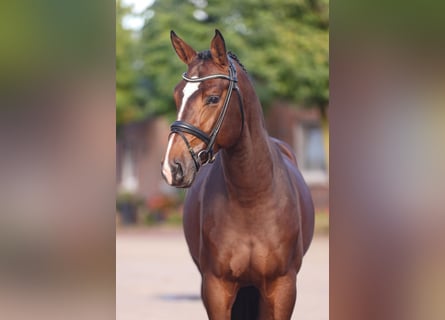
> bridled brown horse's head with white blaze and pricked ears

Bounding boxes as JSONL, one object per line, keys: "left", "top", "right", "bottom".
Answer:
{"left": 161, "top": 30, "right": 244, "bottom": 188}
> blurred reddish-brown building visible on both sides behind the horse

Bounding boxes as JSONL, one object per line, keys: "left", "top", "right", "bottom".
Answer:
{"left": 116, "top": 103, "right": 329, "bottom": 211}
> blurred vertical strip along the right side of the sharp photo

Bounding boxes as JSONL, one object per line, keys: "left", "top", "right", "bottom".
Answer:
{"left": 330, "top": 1, "right": 445, "bottom": 320}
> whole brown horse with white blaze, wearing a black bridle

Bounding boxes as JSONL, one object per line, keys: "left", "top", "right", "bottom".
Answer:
{"left": 162, "top": 30, "right": 314, "bottom": 320}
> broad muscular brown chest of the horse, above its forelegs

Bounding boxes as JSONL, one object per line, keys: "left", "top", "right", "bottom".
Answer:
{"left": 200, "top": 168, "right": 299, "bottom": 283}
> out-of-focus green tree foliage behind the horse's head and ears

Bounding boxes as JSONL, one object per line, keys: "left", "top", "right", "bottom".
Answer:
{"left": 117, "top": 0, "right": 329, "bottom": 125}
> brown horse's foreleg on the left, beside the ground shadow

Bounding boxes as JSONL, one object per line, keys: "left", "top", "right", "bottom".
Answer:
{"left": 201, "top": 274, "right": 238, "bottom": 320}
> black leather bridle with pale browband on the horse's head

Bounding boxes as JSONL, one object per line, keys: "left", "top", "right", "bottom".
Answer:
{"left": 170, "top": 57, "right": 244, "bottom": 171}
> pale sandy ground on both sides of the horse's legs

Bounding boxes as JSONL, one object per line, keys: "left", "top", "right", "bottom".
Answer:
{"left": 116, "top": 228, "right": 329, "bottom": 320}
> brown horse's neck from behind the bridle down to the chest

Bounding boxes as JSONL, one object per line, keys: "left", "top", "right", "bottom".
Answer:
{"left": 222, "top": 73, "right": 273, "bottom": 204}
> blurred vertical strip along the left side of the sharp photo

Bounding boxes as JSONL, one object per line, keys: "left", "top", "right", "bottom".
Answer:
{"left": 0, "top": 0, "right": 115, "bottom": 319}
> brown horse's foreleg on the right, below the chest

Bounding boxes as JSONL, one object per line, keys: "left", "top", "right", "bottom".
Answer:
{"left": 260, "top": 273, "right": 297, "bottom": 320}
